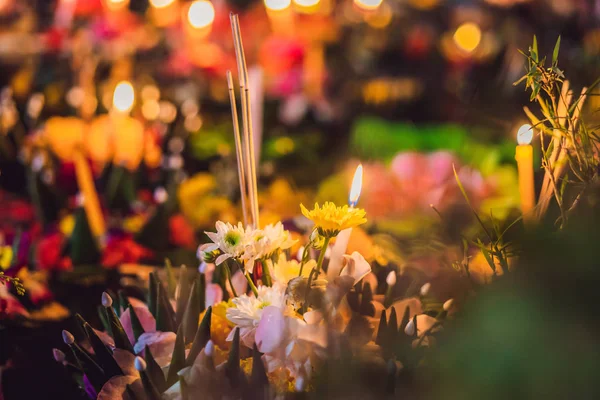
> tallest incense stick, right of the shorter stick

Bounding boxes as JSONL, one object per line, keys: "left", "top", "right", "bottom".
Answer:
{"left": 230, "top": 13, "right": 260, "bottom": 227}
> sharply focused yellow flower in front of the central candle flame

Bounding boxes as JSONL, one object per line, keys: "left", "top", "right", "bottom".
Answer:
{"left": 300, "top": 201, "right": 367, "bottom": 237}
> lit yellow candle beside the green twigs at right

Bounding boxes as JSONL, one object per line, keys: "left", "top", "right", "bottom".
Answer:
{"left": 515, "top": 124, "right": 535, "bottom": 223}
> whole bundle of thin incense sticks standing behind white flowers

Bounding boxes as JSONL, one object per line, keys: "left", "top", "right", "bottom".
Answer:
{"left": 227, "top": 13, "right": 259, "bottom": 228}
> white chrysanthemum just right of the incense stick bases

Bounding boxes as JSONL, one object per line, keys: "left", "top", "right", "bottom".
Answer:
{"left": 243, "top": 222, "right": 296, "bottom": 273}
